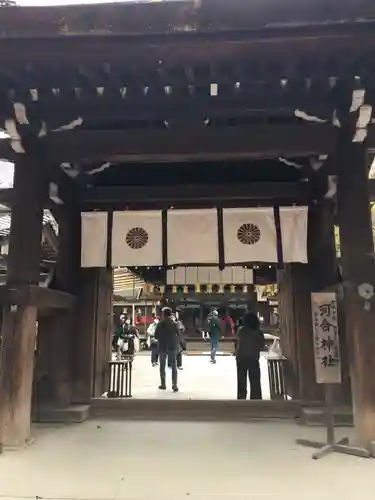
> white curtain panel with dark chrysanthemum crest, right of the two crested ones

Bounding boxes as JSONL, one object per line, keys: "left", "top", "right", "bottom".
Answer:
{"left": 223, "top": 208, "right": 277, "bottom": 265}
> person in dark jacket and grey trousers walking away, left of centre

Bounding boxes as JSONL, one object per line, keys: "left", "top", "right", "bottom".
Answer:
{"left": 155, "top": 307, "right": 180, "bottom": 392}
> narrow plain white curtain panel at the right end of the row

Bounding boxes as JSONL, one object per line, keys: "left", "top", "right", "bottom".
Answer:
{"left": 280, "top": 207, "right": 308, "bottom": 264}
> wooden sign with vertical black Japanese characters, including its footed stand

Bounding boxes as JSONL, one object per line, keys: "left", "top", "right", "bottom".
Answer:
{"left": 296, "top": 292, "right": 372, "bottom": 460}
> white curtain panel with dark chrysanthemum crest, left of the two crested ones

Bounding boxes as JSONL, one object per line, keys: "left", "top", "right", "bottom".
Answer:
{"left": 112, "top": 210, "right": 163, "bottom": 267}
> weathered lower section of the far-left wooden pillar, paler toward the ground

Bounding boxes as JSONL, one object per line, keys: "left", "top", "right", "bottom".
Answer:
{"left": 0, "top": 305, "right": 37, "bottom": 447}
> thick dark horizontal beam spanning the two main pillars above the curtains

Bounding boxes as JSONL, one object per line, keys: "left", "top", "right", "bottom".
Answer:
{"left": 0, "top": 123, "right": 337, "bottom": 164}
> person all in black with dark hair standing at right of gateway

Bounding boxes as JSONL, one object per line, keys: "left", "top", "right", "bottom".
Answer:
{"left": 236, "top": 312, "right": 265, "bottom": 399}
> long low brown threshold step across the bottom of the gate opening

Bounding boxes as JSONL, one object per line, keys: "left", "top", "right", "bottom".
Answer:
{"left": 90, "top": 397, "right": 300, "bottom": 421}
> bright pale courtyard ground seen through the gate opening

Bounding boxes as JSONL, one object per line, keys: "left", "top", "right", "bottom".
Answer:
{"left": 129, "top": 353, "right": 270, "bottom": 399}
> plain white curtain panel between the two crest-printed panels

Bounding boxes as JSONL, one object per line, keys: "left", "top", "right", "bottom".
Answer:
{"left": 167, "top": 209, "right": 219, "bottom": 266}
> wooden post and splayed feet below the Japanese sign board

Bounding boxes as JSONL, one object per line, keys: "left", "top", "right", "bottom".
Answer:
{"left": 296, "top": 384, "right": 371, "bottom": 460}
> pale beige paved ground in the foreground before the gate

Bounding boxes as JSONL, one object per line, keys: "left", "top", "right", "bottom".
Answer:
{"left": 0, "top": 421, "right": 375, "bottom": 500}
